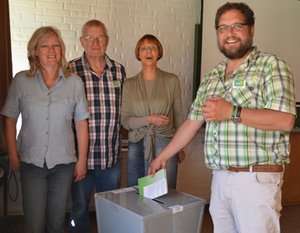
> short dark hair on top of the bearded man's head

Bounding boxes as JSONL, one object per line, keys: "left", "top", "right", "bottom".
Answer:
{"left": 215, "top": 2, "right": 255, "bottom": 29}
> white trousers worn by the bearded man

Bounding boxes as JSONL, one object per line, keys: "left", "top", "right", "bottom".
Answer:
{"left": 209, "top": 170, "right": 283, "bottom": 233}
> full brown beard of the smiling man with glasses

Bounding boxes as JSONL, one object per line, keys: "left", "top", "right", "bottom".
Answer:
{"left": 218, "top": 37, "right": 253, "bottom": 59}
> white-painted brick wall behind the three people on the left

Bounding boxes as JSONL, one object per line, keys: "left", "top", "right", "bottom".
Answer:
{"left": 9, "top": 0, "right": 200, "bottom": 114}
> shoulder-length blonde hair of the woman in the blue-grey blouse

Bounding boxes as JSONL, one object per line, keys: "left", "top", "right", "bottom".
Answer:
{"left": 27, "top": 26, "right": 71, "bottom": 77}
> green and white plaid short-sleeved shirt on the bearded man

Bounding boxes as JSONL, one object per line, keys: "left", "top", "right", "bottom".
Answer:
{"left": 189, "top": 48, "right": 295, "bottom": 169}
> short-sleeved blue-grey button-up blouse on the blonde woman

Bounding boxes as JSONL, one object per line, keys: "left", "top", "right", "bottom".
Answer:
{"left": 1, "top": 70, "right": 89, "bottom": 169}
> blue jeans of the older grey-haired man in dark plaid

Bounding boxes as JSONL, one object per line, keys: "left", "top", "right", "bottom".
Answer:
{"left": 69, "top": 160, "right": 121, "bottom": 233}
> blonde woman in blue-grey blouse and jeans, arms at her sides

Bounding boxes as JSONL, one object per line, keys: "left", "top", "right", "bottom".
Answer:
{"left": 1, "top": 27, "right": 89, "bottom": 233}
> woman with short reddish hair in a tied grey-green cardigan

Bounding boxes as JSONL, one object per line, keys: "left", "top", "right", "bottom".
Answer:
{"left": 121, "top": 34, "right": 184, "bottom": 188}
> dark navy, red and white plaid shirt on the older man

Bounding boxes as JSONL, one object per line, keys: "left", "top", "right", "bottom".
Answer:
{"left": 69, "top": 54, "right": 126, "bottom": 169}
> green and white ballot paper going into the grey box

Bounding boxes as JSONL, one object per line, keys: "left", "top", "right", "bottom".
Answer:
{"left": 138, "top": 169, "right": 168, "bottom": 199}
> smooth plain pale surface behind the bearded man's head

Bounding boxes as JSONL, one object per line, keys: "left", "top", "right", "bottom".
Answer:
{"left": 201, "top": 0, "right": 300, "bottom": 101}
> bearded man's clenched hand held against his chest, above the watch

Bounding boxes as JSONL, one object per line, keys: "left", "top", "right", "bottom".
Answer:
{"left": 201, "top": 97, "right": 233, "bottom": 121}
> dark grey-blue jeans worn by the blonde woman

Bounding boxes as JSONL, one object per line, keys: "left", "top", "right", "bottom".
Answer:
{"left": 20, "top": 162, "right": 74, "bottom": 233}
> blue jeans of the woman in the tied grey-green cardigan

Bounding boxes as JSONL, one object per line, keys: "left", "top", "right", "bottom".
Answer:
{"left": 127, "top": 135, "right": 178, "bottom": 189}
